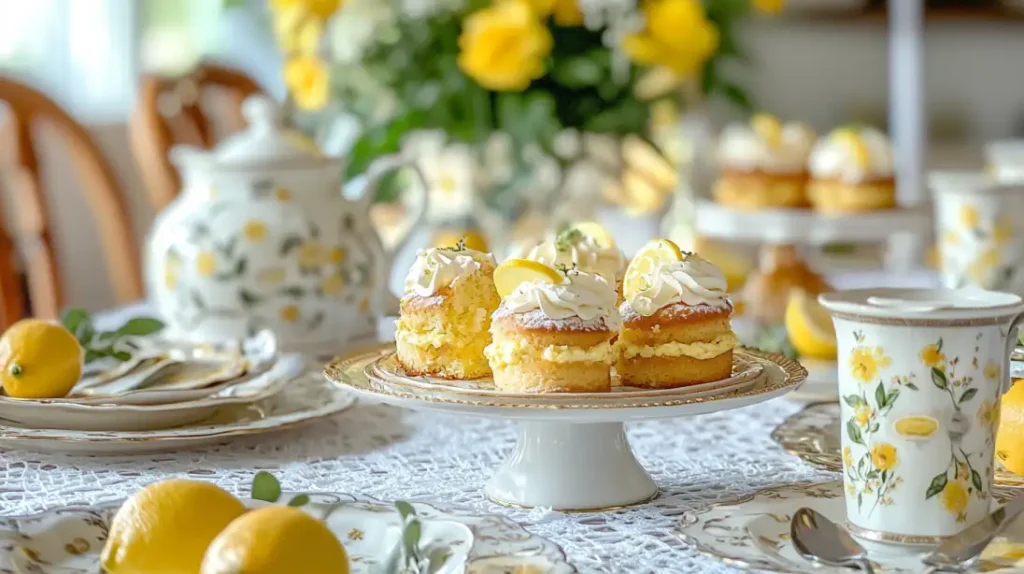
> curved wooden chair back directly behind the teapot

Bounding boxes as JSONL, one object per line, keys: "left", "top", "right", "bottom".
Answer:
{"left": 129, "top": 63, "right": 262, "bottom": 210}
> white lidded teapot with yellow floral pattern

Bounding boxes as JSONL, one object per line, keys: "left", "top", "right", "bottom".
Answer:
{"left": 145, "top": 96, "right": 426, "bottom": 353}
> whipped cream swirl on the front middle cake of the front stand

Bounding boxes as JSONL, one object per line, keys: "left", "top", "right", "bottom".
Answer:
{"left": 504, "top": 270, "right": 621, "bottom": 330}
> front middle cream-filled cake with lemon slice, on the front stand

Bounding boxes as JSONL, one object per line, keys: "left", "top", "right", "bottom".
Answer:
{"left": 484, "top": 260, "right": 620, "bottom": 393}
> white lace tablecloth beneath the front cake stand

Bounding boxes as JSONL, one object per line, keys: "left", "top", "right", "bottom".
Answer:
{"left": 0, "top": 304, "right": 836, "bottom": 573}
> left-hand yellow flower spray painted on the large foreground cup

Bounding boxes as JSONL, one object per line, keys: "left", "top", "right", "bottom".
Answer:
{"left": 843, "top": 332, "right": 919, "bottom": 516}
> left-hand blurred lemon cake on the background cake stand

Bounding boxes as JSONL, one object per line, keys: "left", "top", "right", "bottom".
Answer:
{"left": 712, "top": 114, "right": 814, "bottom": 210}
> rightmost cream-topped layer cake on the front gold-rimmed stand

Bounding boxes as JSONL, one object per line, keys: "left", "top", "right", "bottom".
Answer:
{"left": 615, "top": 239, "right": 736, "bottom": 389}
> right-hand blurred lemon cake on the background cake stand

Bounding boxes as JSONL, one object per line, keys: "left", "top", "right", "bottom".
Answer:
{"left": 808, "top": 127, "right": 896, "bottom": 213}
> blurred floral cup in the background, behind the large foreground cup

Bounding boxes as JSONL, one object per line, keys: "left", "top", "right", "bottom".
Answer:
{"left": 930, "top": 173, "right": 1024, "bottom": 295}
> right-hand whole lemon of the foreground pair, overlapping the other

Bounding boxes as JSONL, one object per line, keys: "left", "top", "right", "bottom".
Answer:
{"left": 200, "top": 506, "right": 348, "bottom": 574}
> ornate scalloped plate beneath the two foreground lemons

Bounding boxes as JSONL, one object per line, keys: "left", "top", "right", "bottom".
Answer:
{"left": 0, "top": 493, "right": 575, "bottom": 574}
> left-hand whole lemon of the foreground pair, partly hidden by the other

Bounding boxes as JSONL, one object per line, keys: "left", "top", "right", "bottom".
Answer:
{"left": 101, "top": 479, "right": 246, "bottom": 574}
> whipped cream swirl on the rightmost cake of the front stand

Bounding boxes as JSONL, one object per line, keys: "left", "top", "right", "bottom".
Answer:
{"left": 629, "top": 255, "right": 729, "bottom": 317}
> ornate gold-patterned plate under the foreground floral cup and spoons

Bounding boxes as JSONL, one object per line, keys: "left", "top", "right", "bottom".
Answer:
{"left": 676, "top": 481, "right": 1024, "bottom": 574}
